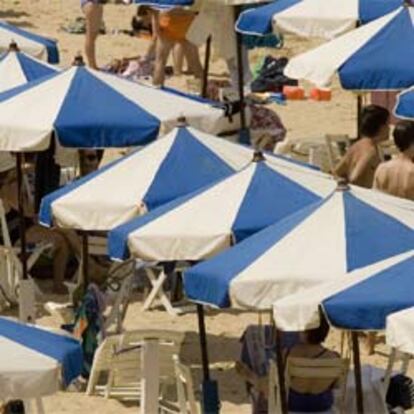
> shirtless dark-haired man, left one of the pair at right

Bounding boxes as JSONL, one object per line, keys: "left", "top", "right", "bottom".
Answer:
{"left": 334, "top": 105, "right": 389, "bottom": 188}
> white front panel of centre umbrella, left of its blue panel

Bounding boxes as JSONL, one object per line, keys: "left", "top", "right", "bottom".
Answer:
{"left": 128, "top": 164, "right": 257, "bottom": 261}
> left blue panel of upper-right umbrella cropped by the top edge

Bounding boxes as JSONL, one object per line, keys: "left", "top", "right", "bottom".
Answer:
{"left": 236, "top": 0, "right": 303, "bottom": 35}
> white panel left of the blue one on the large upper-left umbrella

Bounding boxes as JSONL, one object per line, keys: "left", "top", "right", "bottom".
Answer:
{"left": 0, "top": 68, "right": 75, "bottom": 152}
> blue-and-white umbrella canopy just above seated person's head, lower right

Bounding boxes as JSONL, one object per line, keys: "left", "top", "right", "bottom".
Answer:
{"left": 273, "top": 250, "right": 414, "bottom": 331}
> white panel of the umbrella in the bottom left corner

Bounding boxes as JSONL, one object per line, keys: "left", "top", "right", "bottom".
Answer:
{"left": 0, "top": 336, "right": 60, "bottom": 400}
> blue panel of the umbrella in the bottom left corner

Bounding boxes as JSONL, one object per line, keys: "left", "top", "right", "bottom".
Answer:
{"left": 0, "top": 318, "right": 83, "bottom": 385}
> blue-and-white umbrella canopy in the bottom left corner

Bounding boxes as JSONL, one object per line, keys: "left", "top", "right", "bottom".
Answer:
{"left": 0, "top": 317, "right": 83, "bottom": 400}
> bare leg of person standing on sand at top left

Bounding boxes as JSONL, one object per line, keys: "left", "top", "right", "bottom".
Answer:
{"left": 83, "top": 2, "right": 103, "bottom": 69}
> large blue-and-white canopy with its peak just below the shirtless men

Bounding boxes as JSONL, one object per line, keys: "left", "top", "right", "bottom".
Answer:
{"left": 184, "top": 187, "right": 414, "bottom": 309}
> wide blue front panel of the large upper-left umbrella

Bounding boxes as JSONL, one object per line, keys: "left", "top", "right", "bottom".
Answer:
{"left": 55, "top": 68, "right": 160, "bottom": 148}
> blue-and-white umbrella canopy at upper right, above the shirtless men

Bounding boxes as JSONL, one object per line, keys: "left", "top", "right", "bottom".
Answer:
{"left": 285, "top": 6, "right": 414, "bottom": 91}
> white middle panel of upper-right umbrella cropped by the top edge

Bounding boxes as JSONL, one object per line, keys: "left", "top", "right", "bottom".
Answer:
{"left": 273, "top": 0, "right": 359, "bottom": 39}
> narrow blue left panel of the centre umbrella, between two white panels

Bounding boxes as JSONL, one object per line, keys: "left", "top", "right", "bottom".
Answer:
{"left": 108, "top": 177, "right": 225, "bottom": 260}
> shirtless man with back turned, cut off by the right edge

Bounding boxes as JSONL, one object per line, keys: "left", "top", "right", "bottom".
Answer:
{"left": 374, "top": 121, "right": 414, "bottom": 200}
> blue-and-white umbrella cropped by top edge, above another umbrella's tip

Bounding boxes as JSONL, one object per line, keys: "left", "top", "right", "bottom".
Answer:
{"left": 236, "top": 0, "right": 403, "bottom": 39}
